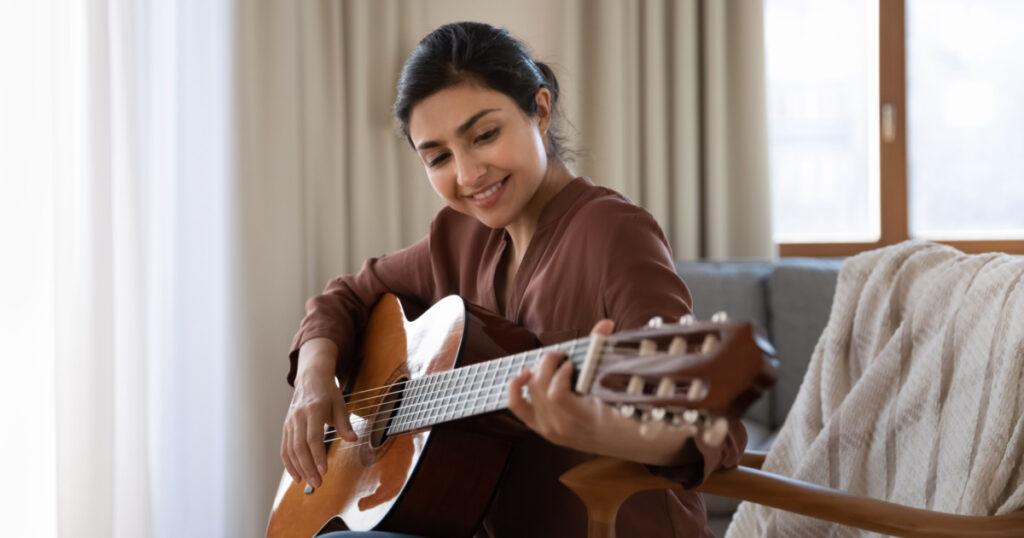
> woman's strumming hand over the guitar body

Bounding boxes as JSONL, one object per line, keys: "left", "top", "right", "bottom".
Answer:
{"left": 281, "top": 338, "right": 358, "bottom": 488}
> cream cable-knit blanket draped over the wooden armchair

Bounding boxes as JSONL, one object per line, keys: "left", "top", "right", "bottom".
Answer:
{"left": 726, "top": 241, "right": 1024, "bottom": 538}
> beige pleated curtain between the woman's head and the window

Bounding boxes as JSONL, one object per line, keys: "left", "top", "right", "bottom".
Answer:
{"left": 567, "top": 0, "right": 774, "bottom": 258}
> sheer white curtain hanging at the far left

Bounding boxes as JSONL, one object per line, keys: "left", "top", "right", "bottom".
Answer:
{"left": 0, "top": 0, "right": 253, "bottom": 537}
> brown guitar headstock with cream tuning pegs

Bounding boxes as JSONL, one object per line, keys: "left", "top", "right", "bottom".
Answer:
{"left": 590, "top": 313, "right": 775, "bottom": 444}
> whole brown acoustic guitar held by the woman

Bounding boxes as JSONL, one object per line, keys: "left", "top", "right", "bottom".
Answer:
{"left": 267, "top": 295, "right": 775, "bottom": 538}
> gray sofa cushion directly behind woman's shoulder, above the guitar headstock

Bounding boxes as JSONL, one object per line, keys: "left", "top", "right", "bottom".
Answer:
{"left": 676, "top": 261, "right": 774, "bottom": 424}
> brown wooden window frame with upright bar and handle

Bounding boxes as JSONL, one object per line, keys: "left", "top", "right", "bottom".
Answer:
{"left": 778, "top": 0, "right": 1024, "bottom": 257}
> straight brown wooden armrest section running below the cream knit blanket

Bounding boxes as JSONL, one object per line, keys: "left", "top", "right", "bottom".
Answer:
{"left": 697, "top": 463, "right": 1024, "bottom": 538}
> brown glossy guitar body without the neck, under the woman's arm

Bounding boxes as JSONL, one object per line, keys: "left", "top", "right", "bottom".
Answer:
{"left": 267, "top": 295, "right": 537, "bottom": 538}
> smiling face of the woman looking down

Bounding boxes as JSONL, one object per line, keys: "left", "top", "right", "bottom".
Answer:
{"left": 409, "top": 84, "right": 550, "bottom": 229}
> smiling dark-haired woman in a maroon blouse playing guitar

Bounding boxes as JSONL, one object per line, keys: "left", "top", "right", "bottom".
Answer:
{"left": 282, "top": 23, "right": 745, "bottom": 537}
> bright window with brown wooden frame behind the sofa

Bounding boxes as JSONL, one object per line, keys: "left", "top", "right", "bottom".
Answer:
{"left": 765, "top": 0, "right": 1024, "bottom": 256}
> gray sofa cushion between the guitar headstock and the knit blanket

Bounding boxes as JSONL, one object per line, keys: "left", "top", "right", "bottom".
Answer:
{"left": 767, "top": 258, "right": 843, "bottom": 429}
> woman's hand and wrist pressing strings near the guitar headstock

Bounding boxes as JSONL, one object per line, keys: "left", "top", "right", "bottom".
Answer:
{"left": 509, "top": 320, "right": 694, "bottom": 465}
